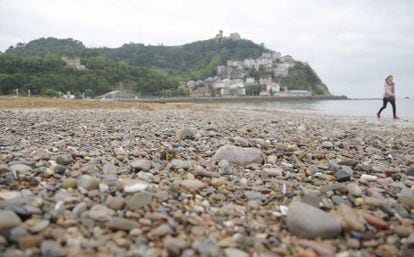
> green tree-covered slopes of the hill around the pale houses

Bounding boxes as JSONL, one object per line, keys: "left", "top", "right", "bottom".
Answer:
{"left": 0, "top": 38, "right": 329, "bottom": 96}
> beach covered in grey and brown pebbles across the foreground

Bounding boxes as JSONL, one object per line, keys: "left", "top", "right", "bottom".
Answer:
{"left": 0, "top": 108, "right": 414, "bottom": 257}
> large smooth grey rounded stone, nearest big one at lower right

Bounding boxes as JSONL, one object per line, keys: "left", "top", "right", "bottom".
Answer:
{"left": 287, "top": 201, "right": 342, "bottom": 238}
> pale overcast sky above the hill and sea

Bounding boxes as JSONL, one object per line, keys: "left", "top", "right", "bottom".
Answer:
{"left": 0, "top": 0, "right": 414, "bottom": 97}
